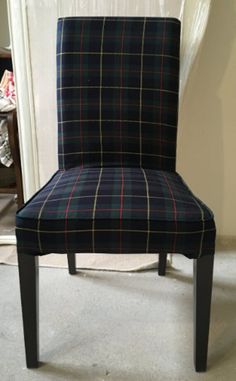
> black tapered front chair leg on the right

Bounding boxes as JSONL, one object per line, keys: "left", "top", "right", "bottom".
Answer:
{"left": 194, "top": 255, "right": 214, "bottom": 372}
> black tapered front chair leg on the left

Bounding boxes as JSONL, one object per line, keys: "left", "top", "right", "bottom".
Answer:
{"left": 18, "top": 254, "right": 39, "bottom": 368}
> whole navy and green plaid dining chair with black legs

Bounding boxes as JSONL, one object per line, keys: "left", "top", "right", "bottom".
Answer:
{"left": 16, "top": 17, "right": 215, "bottom": 371}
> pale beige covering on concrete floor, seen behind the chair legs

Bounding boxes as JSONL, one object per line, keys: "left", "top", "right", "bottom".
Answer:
{"left": 0, "top": 245, "right": 162, "bottom": 271}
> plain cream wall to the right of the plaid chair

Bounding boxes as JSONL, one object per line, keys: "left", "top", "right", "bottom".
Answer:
{"left": 178, "top": 0, "right": 236, "bottom": 236}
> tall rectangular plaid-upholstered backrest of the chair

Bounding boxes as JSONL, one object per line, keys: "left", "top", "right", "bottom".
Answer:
{"left": 57, "top": 17, "right": 180, "bottom": 171}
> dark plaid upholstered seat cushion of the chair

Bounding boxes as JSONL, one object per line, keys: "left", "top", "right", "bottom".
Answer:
{"left": 16, "top": 167, "right": 215, "bottom": 258}
